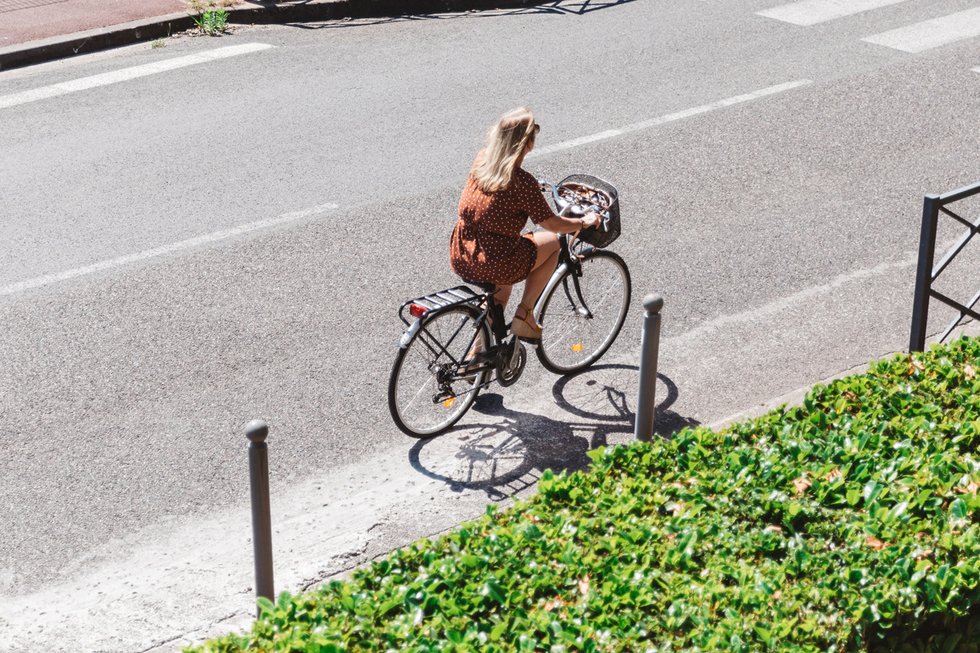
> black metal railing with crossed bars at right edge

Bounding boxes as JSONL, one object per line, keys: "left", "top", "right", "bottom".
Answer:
{"left": 909, "top": 182, "right": 980, "bottom": 351}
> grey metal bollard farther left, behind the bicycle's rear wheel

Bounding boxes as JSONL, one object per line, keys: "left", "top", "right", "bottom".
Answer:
{"left": 245, "top": 420, "right": 275, "bottom": 617}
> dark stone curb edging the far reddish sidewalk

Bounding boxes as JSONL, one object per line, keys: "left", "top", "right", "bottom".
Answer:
{"left": 0, "top": 0, "right": 544, "bottom": 71}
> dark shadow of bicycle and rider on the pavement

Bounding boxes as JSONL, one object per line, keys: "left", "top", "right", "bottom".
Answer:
{"left": 409, "top": 365, "right": 699, "bottom": 501}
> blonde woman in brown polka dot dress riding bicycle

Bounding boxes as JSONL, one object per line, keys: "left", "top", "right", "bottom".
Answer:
{"left": 449, "top": 107, "right": 601, "bottom": 341}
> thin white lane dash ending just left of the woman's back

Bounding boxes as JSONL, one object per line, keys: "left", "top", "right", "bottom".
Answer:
{"left": 0, "top": 204, "right": 339, "bottom": 297}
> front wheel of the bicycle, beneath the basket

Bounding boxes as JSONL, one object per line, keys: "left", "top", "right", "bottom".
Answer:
{"left": 536, "top": 250, "right": 632, "bottom": 374}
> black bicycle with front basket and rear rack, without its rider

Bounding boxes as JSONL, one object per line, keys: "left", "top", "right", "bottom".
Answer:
{"left": 388, "top": 175, "right": 632, "bottom": 438}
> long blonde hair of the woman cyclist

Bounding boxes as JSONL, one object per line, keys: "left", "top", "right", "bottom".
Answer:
{"left": 470, "top": 107, "right": 538, "bottom": 193}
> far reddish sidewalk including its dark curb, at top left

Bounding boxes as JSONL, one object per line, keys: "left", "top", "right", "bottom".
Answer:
{"left": 0, "top": 0, "right": 541, "bottom": 71}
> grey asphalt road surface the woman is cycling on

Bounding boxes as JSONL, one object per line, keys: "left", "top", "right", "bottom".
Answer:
{"left": 0, "top": 0, "right": 980, "bottom": 650}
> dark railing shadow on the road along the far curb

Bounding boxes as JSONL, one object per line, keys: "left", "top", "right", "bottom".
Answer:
{"left": 253, "top": 0, "right": 635, "bottom": 30}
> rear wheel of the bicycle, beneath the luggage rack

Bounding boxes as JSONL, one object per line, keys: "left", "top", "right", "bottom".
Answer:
{"left": 388, "top": 306, "right": 491, "bottom": 438}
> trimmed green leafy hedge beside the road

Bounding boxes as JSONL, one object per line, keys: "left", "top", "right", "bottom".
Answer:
{"left": 194, "top": 339, "right": 980, "bottom": 653}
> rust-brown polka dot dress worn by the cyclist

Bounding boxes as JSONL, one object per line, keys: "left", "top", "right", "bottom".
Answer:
{"left": 449, "top": 168, "right": 555, "bottom": 285}
